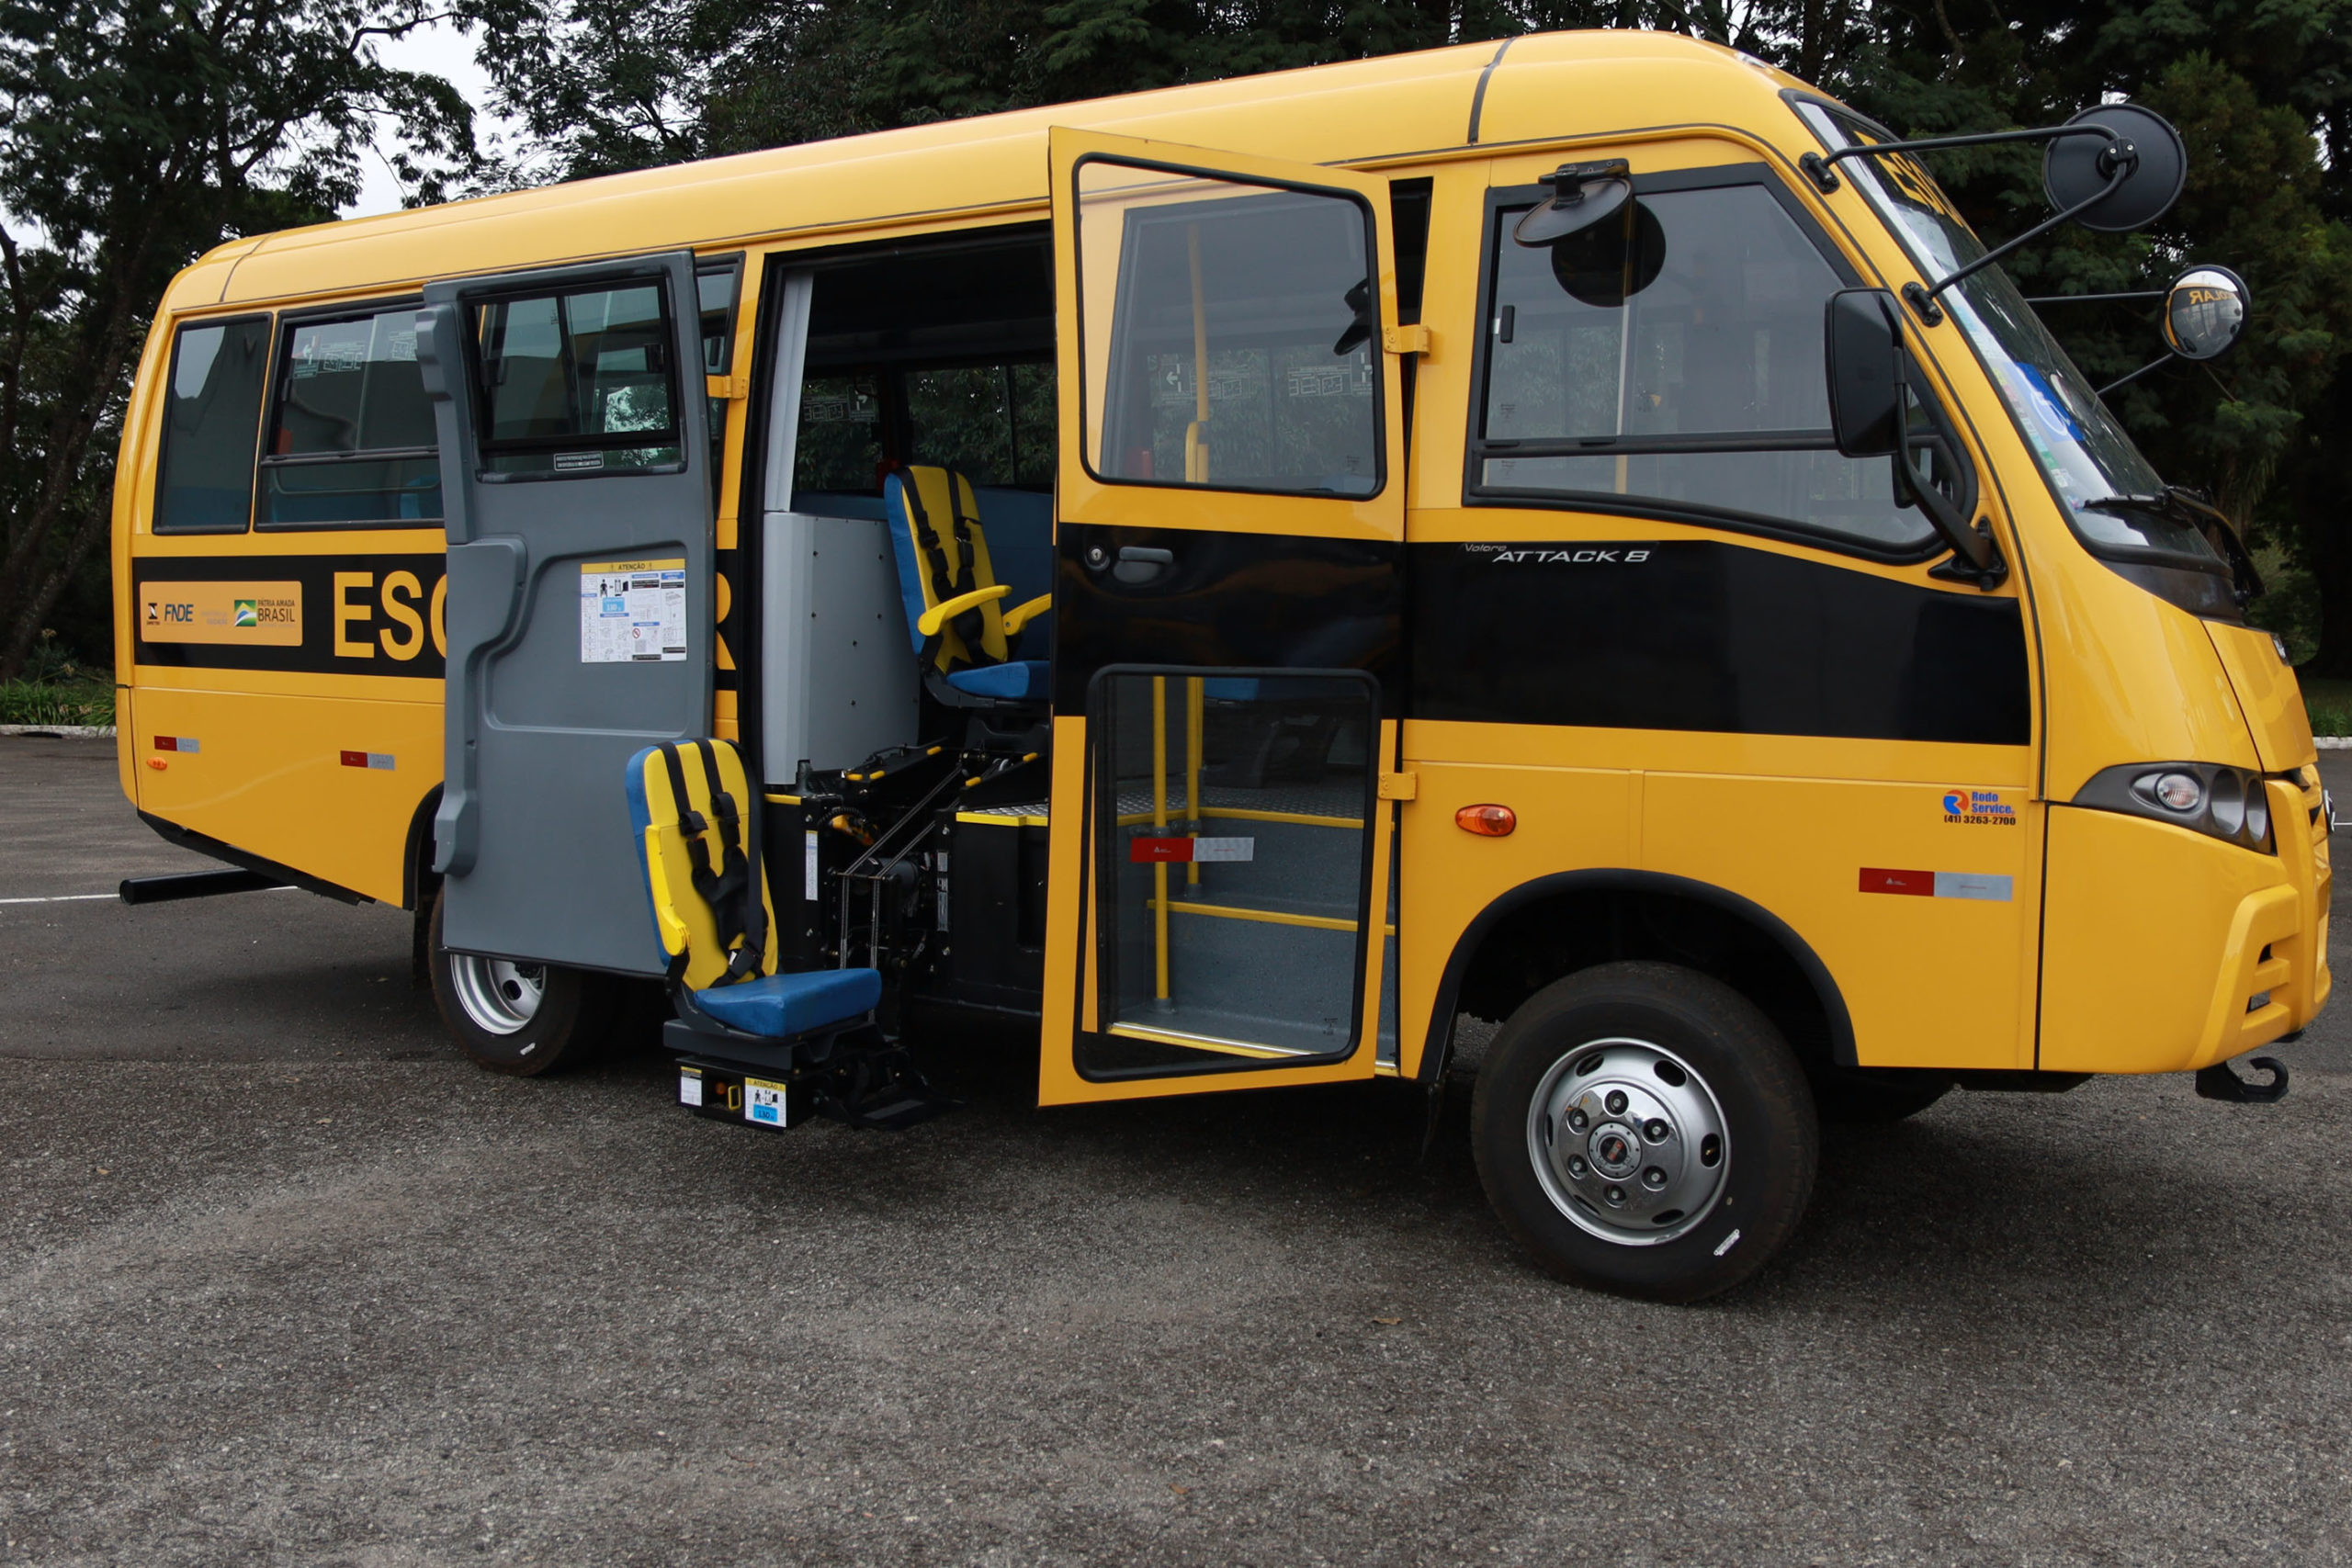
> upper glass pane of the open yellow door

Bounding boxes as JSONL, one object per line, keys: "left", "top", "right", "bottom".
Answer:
{"left": 1077, "top": 160, "right": 1381, "bottom": 496}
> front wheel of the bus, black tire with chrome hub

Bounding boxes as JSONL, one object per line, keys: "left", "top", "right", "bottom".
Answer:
{"left": 1470, "top": 962, "right": 1820, "bottom": 1303}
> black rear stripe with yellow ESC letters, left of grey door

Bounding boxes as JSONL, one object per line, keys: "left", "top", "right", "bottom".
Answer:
{"left": 131, "top": 550, "right": 445, "bottom": 682}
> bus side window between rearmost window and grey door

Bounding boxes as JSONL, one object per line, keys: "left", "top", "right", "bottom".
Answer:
{"left": 259, "top": 306, "right": 442, "bottom": 529}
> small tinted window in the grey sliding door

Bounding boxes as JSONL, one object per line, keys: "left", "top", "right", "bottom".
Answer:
{"left": 475, "top": 282, "right": 682, "bottom": 472}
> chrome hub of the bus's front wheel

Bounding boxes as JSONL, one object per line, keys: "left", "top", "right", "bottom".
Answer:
{"left": 1526, "top": 1039, "right": 1731, "bottom": 1246}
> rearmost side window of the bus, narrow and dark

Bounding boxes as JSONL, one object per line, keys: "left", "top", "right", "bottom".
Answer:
{"left": 151, "top": 315, "right": 270, "bottom": 534}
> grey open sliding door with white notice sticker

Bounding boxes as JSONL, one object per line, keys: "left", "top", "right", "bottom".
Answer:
{"left": 421, "top": 252, "right": 713, "bottom": 974}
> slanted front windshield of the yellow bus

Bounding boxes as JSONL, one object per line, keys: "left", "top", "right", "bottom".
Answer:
{"left": 1799, "top": 104, "right": 2218, "bottom": 559}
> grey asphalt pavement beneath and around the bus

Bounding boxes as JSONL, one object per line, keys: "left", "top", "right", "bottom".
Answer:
{"left": 0, "top": 739, "right": 2352, "bottom": 1565}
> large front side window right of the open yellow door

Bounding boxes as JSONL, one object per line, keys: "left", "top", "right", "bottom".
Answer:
{"left": 1477, "top": 184, "right": 1928, "bottom": 547}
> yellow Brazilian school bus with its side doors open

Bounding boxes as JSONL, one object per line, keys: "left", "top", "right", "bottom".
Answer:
{"left": 113, "top": 30, "right": 2331, "bottom": 1300}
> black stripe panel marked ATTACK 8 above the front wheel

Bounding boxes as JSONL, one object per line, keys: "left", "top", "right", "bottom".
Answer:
{"left": 1407, "top": 541, "right": 2032, "bottom": 745}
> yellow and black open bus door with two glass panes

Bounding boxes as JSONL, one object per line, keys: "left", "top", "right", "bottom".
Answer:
{"left": 1040, "top": 130, "right": 1404, "bottom": 1105}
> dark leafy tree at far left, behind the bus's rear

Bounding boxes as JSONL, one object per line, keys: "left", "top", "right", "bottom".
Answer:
{"left": 0, "top": 0, "right": 475, "bottom": 677}
